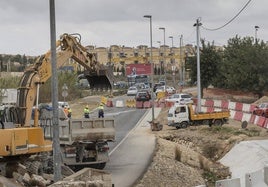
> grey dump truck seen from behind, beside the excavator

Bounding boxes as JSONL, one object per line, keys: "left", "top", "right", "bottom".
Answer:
{"left": 36, "top": 104, "right": 115, "bottom": 171}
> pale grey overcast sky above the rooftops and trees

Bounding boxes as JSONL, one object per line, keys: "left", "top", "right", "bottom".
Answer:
{"left": 0, "top": 0, "right": 268, "bottom": 55}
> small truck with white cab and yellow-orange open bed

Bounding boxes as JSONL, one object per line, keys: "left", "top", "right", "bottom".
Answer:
{"left": 167, "top": 104, "right": 230, "bottom": 129}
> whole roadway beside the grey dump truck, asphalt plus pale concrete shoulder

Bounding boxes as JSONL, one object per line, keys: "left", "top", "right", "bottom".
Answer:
{"left": 96, "top": 97, "right": 160, "bottom": 187}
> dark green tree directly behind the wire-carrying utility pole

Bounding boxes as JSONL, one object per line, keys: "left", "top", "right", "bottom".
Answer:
{"left": 186, "top": 40, "right": 222, "bottom": 95}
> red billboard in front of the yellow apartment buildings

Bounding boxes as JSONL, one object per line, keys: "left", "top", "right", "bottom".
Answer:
{"left": 126, "top": 64, "right": 151, "bottom": 75}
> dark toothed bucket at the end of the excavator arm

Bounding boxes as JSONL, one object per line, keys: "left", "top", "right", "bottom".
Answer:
{"left": 84, "top": 66, "right": 114, "bottom": 91}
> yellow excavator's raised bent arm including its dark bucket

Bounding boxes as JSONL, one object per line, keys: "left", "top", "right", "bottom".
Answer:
{"left": 15, "top": 34, "right": 113, "bottom": 126}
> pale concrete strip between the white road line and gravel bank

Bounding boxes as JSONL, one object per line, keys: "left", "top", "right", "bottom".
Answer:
{"left": 106, "top": 108, "right": 161, "bottom": 187}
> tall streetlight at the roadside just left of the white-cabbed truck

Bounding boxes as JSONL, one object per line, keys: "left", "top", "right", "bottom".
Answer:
{"left": 143, "top": 15, "right": 154, "bottom": 123}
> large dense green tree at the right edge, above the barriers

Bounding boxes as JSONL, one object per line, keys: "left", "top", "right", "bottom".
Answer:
{"left": 218, "top": 36, "right": 268, "bottom": 97}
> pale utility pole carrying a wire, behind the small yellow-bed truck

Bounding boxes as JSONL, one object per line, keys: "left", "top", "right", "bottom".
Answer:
{"left": 194, "top": 18, "right": 202, "bottom": 113}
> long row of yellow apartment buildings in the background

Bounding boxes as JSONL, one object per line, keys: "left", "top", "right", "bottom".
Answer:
{"left": 77, "top": 45, "right": 195, "bottom": 73}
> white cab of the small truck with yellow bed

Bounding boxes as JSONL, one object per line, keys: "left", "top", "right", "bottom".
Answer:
{"left": 168, "top": 104, "right": 190, "bottom": 129}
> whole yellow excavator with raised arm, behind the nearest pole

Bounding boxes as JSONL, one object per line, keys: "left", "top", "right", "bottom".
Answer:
{"left": 0, "top": 34, "right": 113, "bottom": 175}
